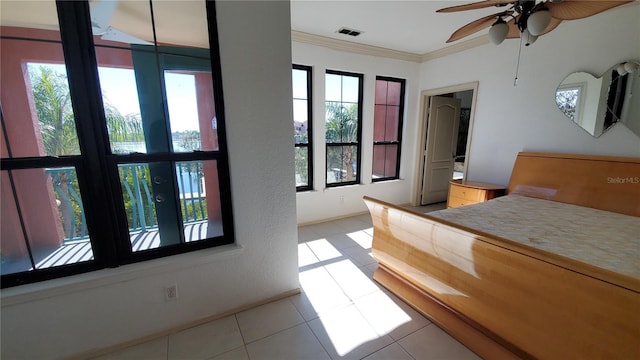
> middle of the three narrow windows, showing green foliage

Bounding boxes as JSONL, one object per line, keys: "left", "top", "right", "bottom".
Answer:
{"left": 325, "top": 70, "right": 363, "bottom": 187}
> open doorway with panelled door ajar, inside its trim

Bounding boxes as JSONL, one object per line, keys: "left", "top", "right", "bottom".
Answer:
{"left": 414, "top": 82, "right": 478, "bottom": 205}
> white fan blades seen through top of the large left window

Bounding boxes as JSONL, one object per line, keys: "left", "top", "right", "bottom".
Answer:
{"left": 91, "top": 0, "right": 152, "bottom": 45}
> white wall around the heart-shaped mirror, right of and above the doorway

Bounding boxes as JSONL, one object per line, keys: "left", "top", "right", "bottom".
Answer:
{"left": 420, "top": 5, "right": 640, "bottom": 184}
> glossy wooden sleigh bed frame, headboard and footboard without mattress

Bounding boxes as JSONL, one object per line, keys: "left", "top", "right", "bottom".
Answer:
{"left": 364, "top": 153, "right": 640, "bottom": 359}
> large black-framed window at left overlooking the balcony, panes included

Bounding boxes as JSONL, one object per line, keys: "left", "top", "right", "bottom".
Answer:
{"left": 0, "top": 0, "right": 234, "bottom": 287}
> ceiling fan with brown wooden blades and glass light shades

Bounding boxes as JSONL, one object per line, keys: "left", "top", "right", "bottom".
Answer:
{"left": 436, "top": 0, "right": 633, "bottom": 45}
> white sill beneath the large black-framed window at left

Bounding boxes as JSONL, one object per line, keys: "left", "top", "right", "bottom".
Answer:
{"left": 0, "top": 244, "right": 243, "bottom": 307}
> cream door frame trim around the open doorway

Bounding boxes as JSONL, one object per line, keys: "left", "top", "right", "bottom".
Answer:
{"left": 411, "top": 81, "right": 479, "bottom": 206}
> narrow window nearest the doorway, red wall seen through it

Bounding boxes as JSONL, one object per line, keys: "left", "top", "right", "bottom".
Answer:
{"left": 372, "top": 76, "right": 404, "bottom": 181}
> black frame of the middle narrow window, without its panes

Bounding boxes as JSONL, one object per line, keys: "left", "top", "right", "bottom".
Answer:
{"left": 324, "top": 69, "right": 364, "bottom": 188}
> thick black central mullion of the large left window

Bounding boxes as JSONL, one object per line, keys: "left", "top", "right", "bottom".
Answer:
{"left": 56, "top": 0, "right": 118, "bottom": 266}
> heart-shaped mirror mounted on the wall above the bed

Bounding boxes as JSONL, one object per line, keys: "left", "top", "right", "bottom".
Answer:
{"left": 556, "top": 61, "right": 640, "bottom": 137}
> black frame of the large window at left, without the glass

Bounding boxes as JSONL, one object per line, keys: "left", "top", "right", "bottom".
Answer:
{"left": 0, "top": 0, "right": 235, "bottom": 288}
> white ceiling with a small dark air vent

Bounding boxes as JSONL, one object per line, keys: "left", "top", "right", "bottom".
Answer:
{"left": 291, "top": 0, "right": 510, "bottom": 55}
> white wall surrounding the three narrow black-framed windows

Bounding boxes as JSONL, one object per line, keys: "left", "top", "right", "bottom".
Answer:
{"left": 292, "top": 42, "right": 419, "bottom": 224}
